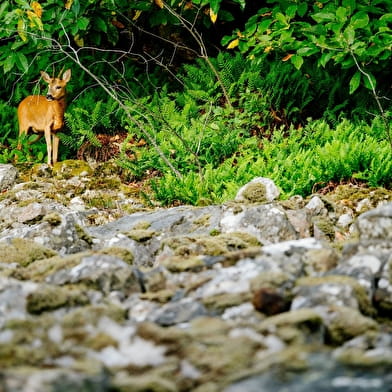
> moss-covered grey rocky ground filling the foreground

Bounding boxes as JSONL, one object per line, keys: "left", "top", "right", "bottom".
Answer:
{"left": 0, "top": 161, "right": 392, "bottom": 392}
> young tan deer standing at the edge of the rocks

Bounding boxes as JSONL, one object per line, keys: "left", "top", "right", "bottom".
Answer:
{"left": 18, "top": 69, "right": 71, "bottom": 165}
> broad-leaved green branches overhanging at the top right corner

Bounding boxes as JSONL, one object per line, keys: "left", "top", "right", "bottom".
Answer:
{"left": 223, "top": 0, "right": 392, "bottom": 114}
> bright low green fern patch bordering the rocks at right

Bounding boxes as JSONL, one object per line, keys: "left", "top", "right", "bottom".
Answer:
{"left": 149, "top": 120, "right": 392, "bottom": 204}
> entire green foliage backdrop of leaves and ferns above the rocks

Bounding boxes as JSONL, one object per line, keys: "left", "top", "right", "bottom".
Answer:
{"left": 0, "top": 0, "right": 392, "bottom": 203}
